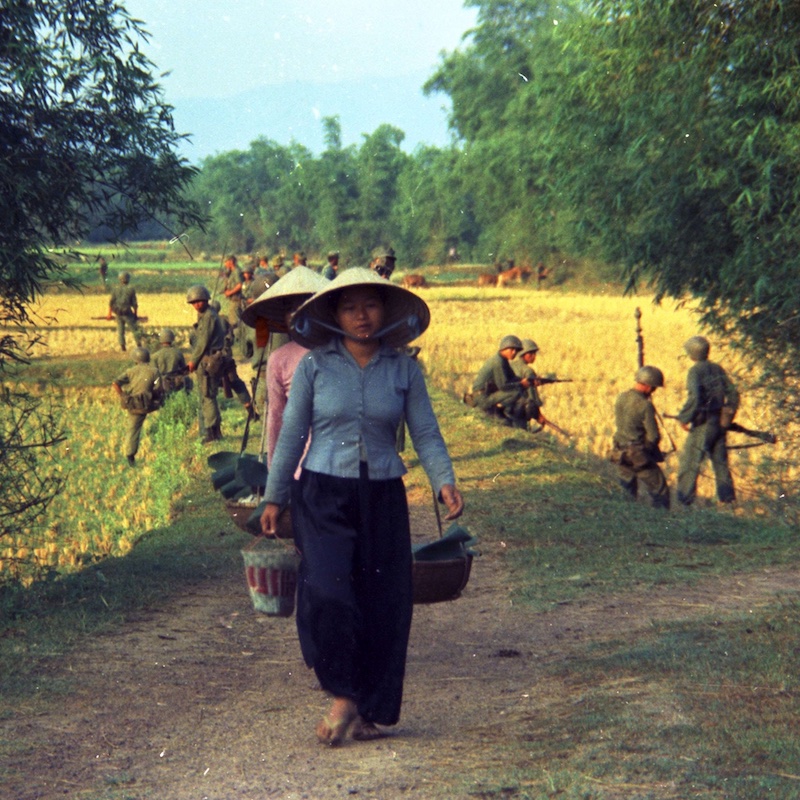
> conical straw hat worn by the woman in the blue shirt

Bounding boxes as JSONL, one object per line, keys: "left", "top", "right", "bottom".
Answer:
{"left": 290, "top": 267, "right": 431, "bottom": 349}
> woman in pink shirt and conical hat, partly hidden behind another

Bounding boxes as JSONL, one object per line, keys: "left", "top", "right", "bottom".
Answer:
{"left": 242, "top": 267, "right": 328, "bottom": 468}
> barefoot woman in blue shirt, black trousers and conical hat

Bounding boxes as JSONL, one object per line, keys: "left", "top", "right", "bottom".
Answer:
{"left": 261, "top": 267, "right": 464, "bottom": 745}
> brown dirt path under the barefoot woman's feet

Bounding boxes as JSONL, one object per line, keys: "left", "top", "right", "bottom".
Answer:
{"left": 0, "top": 511, "right": 798, "bottom": 800}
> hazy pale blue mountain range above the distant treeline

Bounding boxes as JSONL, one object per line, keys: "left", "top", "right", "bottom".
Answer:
{"left": 168, "top": 74, "right": 460, "bottom": 164}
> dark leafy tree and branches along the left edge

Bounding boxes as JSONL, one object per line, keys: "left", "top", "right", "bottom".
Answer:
{"left": 0, "top": 0, "right": 202, "bottom": 535}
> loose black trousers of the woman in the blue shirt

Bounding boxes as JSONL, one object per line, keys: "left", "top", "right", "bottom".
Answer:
{"left": 292, "top": 465, "right": 413, "bottom": 725}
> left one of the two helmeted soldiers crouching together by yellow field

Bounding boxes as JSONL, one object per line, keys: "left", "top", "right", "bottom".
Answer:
{"left": 472, "top": 334, "right": 541, "bottom": 429}
